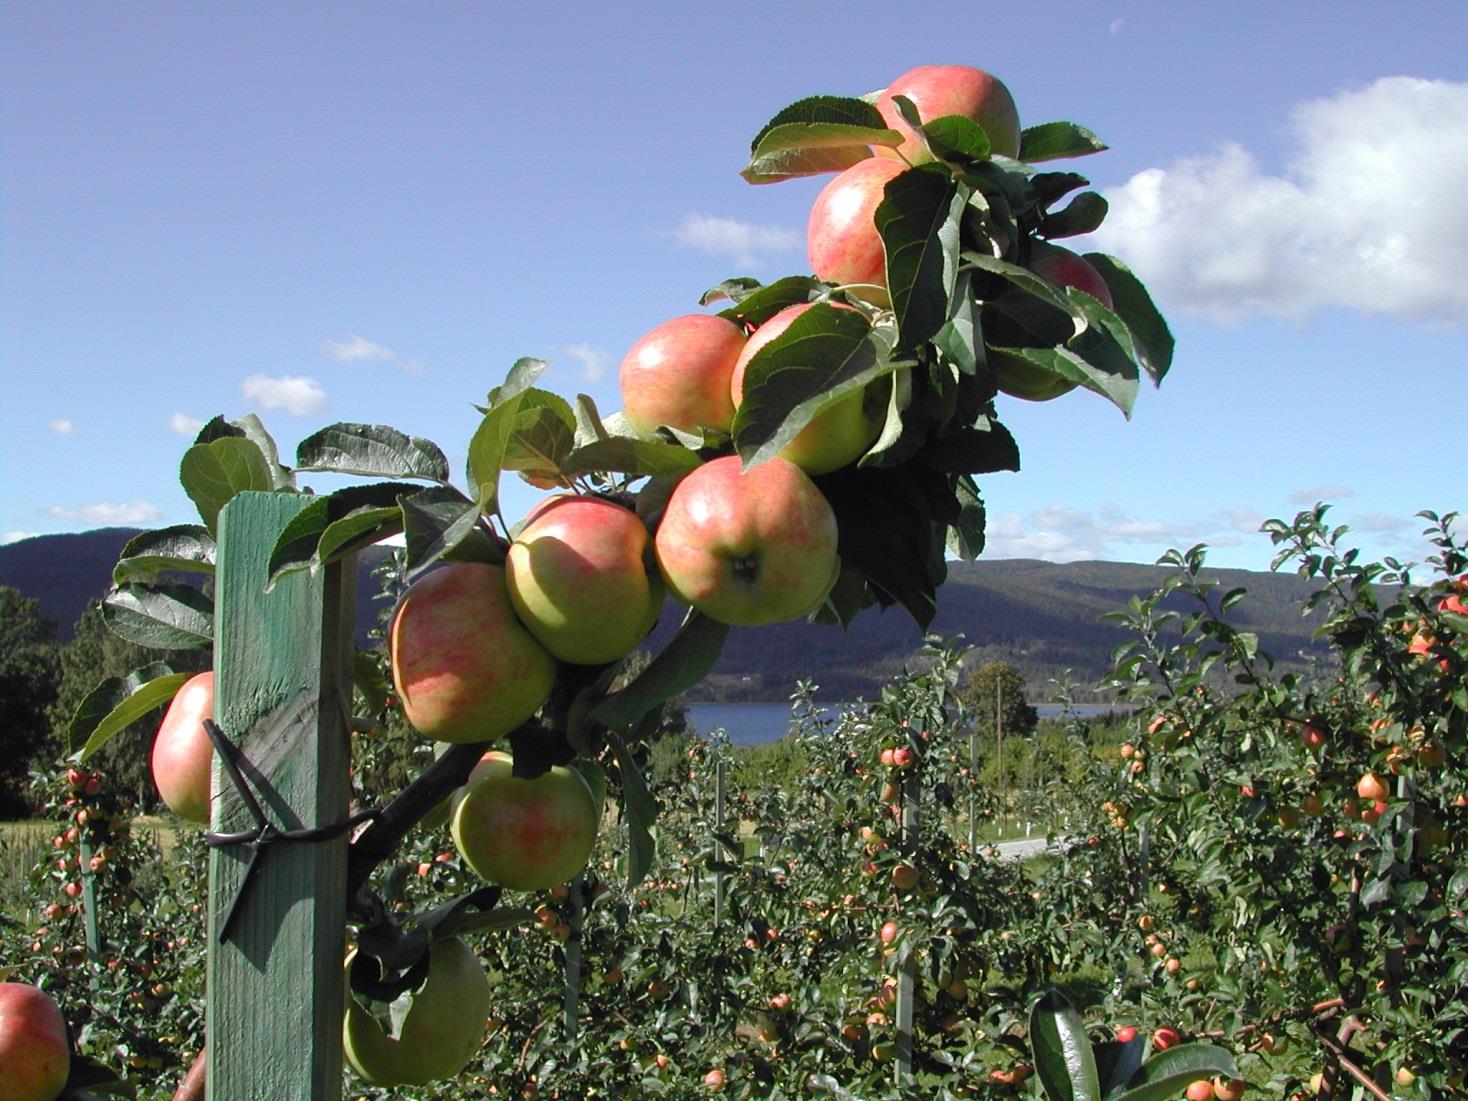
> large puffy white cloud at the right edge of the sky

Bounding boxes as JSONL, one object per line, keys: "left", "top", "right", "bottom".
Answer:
{"left": 1094, "top": 76, "right": 1468, "bottom": 324}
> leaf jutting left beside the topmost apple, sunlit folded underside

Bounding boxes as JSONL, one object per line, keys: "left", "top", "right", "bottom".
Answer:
{"left": 740, "top": 95, "right": 903, "bottom": 184}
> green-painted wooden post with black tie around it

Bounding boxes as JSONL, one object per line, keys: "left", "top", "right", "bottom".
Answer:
{"left": 206, "top": 493, "right": 354, "bottom": 1101}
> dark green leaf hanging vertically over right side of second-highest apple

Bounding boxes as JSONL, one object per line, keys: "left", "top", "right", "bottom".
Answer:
{"left": 875, "top": 167, "right": 969, "bottom": 352}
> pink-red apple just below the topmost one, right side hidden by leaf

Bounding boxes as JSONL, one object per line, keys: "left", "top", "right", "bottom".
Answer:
{"left": 806, "top": 157, "right": 907, "bottom": 307}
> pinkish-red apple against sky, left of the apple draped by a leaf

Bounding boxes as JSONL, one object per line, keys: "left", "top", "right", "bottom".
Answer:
{"left": 619, "top": 314, "right": 744, "bottom": 433}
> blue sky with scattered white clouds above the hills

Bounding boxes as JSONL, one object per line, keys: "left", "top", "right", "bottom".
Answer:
{"left": 0, "top": 0, "right": 1468, "bottom": 578}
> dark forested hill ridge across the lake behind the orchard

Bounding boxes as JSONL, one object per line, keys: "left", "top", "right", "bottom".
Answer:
{"left": 0, "top": 528, "right": 1317, "bottom": 700}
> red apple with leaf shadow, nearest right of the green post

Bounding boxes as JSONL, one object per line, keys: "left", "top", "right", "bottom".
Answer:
{"left": 389, "top": 562, "right": 556, "bottom": 743}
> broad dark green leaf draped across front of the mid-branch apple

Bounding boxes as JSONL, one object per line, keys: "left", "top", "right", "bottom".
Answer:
{"left": 734, "top": 302, "right": 904, "bottom": 467}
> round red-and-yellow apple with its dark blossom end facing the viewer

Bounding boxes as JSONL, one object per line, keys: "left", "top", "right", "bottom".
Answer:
{"left": 653, "top": 455, "right": 841, "bottom": 627}
